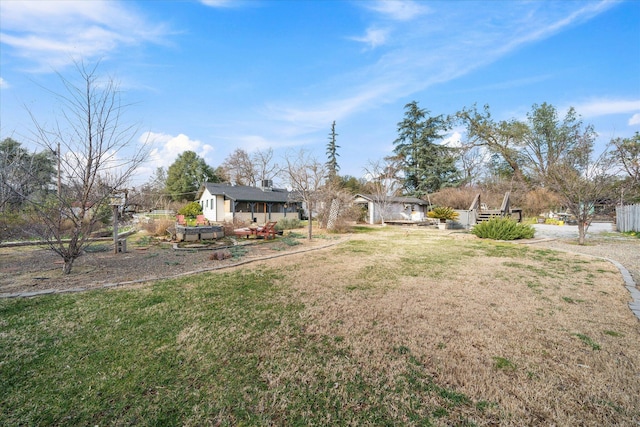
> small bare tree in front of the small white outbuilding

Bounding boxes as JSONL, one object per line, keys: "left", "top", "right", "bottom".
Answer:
{"left": 364, "top": 158, "right": 402, "bottom": 224}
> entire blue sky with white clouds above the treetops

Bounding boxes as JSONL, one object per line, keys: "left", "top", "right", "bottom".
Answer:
{"left": 0, "top": 0, "right": 640, "bottom": 183}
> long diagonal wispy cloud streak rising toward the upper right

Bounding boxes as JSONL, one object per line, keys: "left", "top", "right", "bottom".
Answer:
{"left": 262, "top": 1, "right": 614, "bottom": 134}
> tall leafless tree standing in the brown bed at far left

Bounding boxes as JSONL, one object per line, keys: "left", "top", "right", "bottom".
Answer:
{"left": 30, "top": 63, "right": 148, "bottom": 274}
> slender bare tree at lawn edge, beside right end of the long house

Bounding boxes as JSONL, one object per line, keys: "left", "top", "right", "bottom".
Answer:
{"left": 283, "top": 150, "right": 326, "bottom": 240}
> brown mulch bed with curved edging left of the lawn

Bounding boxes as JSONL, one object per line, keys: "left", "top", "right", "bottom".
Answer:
{"left": 0, "top": 234, "right": 340, "bottom": 296}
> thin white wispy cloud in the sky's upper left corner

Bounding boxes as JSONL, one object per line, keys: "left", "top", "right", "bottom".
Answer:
{"left": 0, "top": 0, "right": 167, "bottom": 71}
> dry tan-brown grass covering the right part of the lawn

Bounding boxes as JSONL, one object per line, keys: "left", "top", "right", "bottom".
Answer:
{"left": 248, "top": 229, "right": 640, "bottom": 425}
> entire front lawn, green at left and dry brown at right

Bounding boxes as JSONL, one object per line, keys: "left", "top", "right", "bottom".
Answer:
{"left": 0, "top": 229, "right": 640, "bottom": 426}
